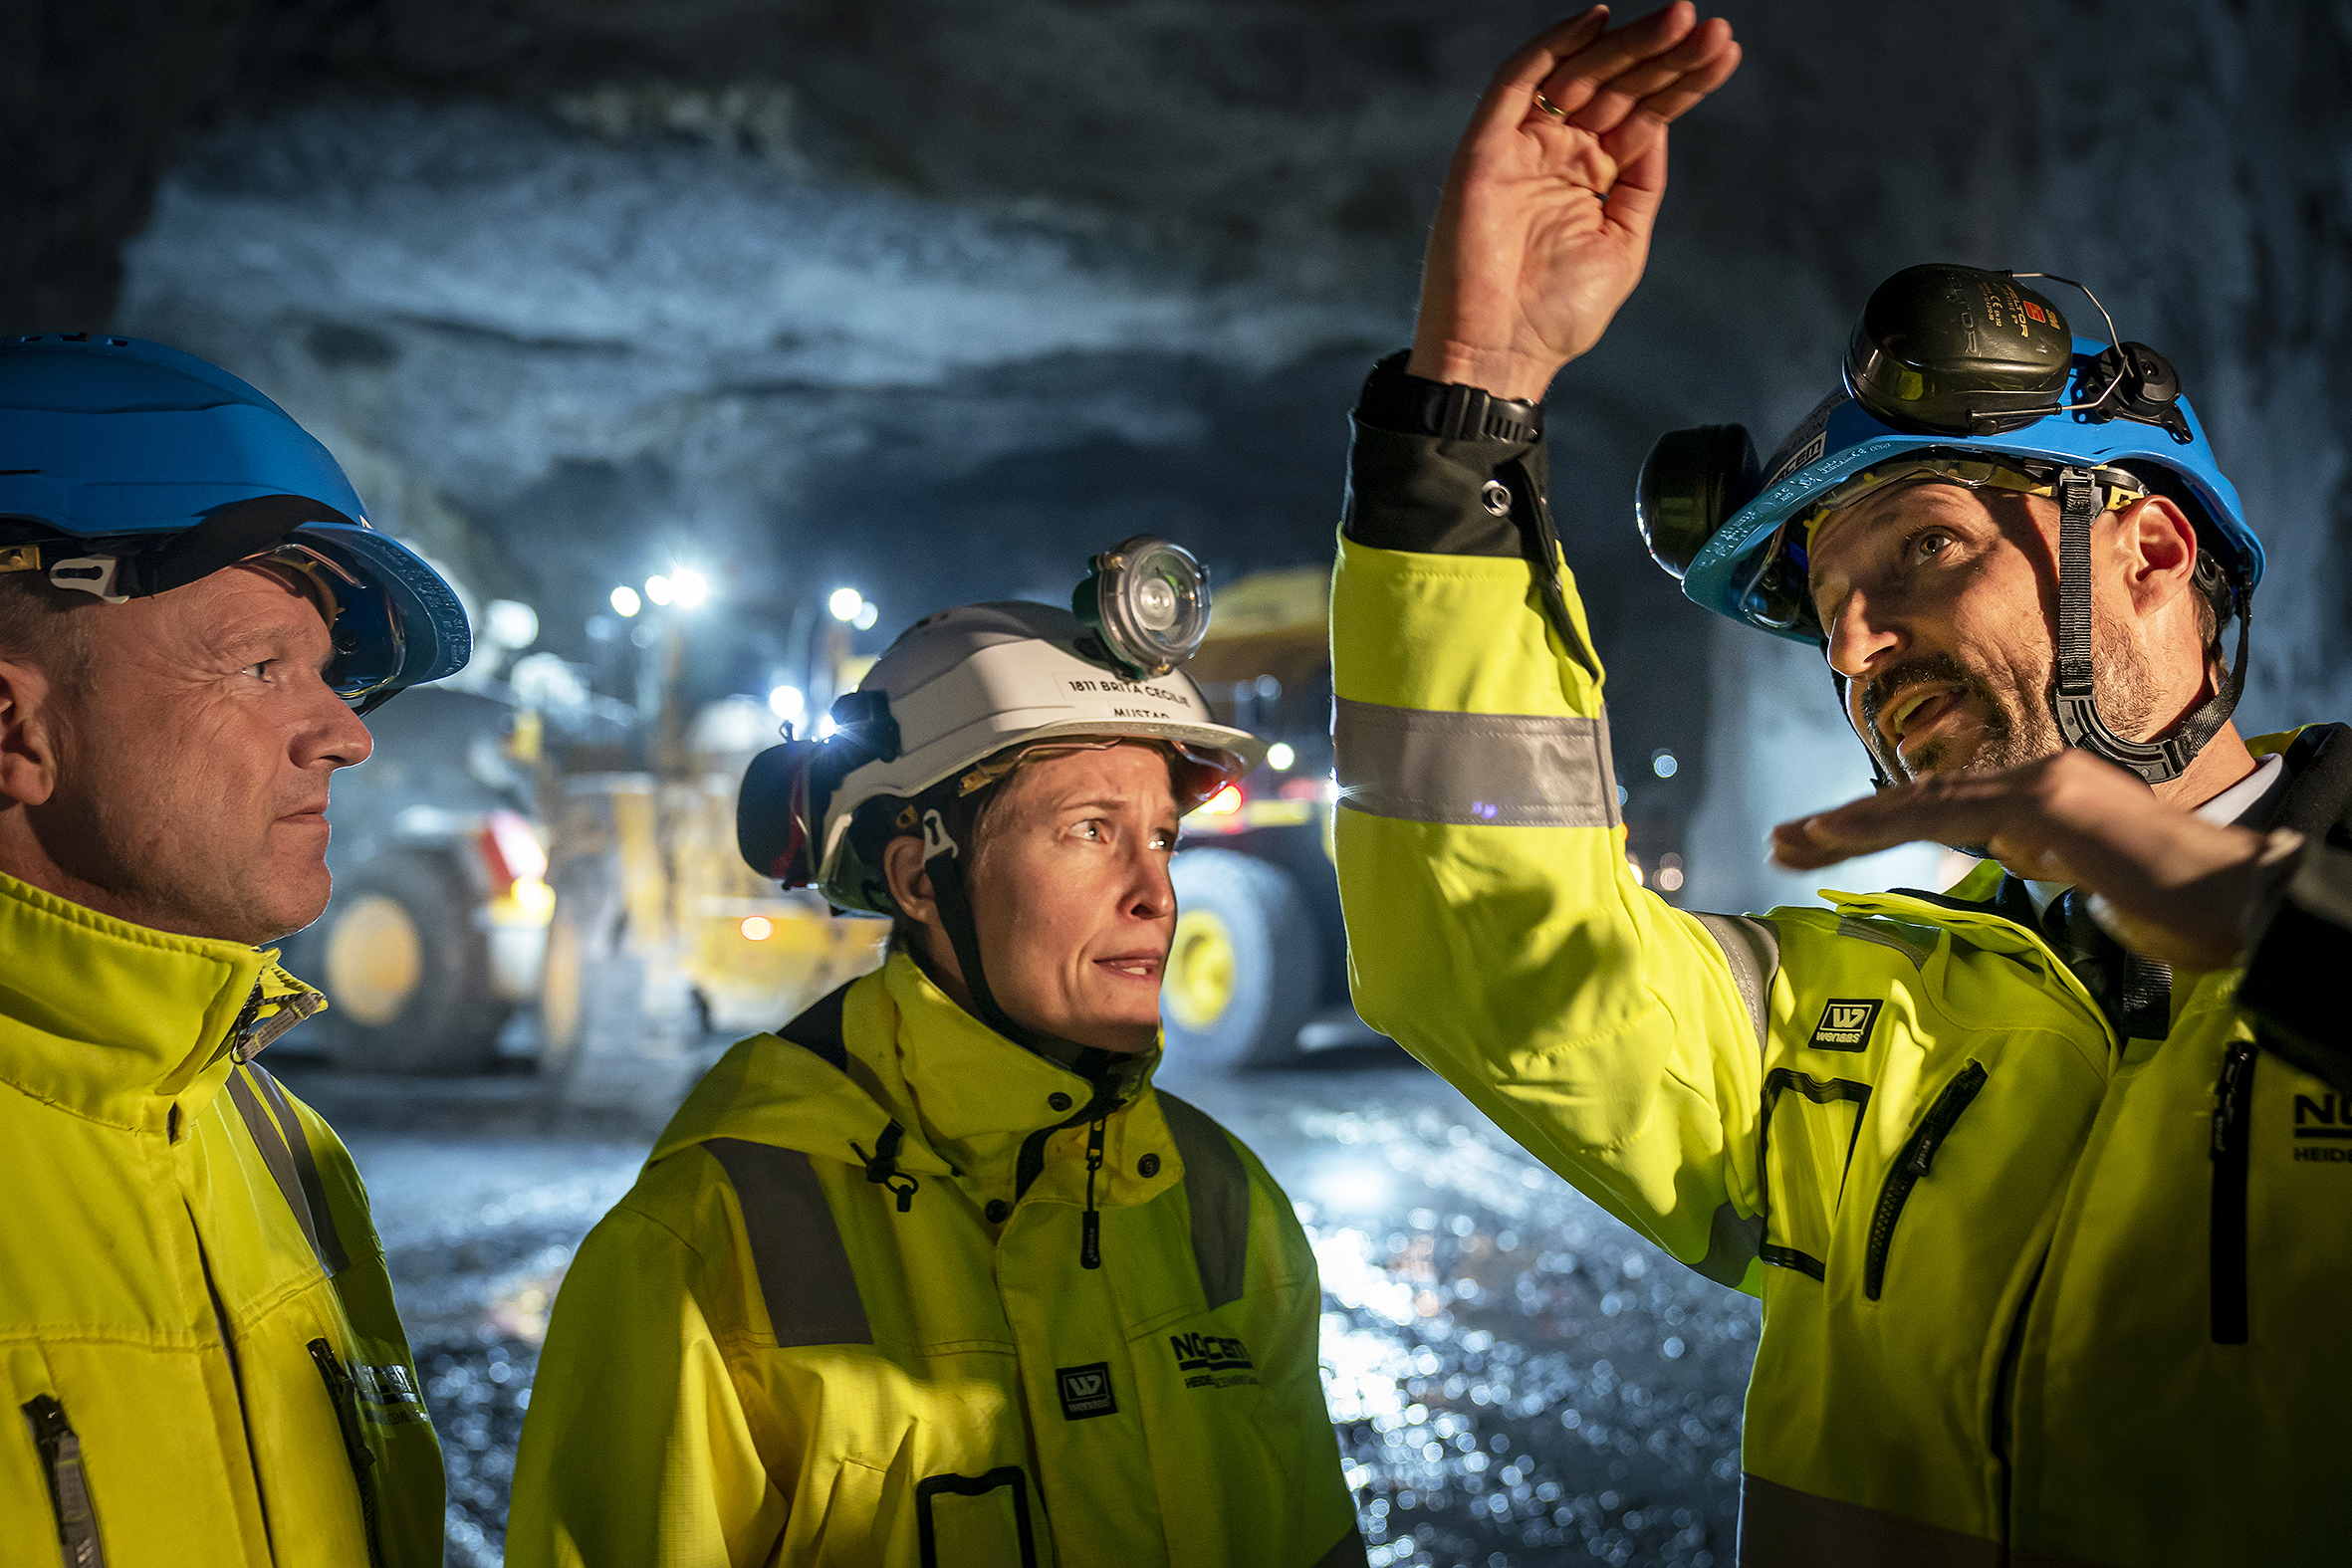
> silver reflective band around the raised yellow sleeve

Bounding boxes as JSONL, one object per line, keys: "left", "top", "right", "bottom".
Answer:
{"left": 1331, "top": 698, "right": 1620, "bottom": 827}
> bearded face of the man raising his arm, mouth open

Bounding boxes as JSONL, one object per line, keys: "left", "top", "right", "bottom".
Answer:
{"left": 1808, "top": 482, "right": 2150, "bottom": 781}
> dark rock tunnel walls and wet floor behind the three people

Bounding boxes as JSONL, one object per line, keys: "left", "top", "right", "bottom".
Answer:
{"left": 18, "top": 0, "right": 2352, "bottom": 1568}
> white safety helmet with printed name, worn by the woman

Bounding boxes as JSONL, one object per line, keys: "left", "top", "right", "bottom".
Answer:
{"left": 736, "top": 563, "right": 1266, "bottom": 915}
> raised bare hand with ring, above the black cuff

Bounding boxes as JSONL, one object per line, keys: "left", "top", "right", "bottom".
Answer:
{"left": 1409, "top": 0, "right": 1741, "bottom": 399}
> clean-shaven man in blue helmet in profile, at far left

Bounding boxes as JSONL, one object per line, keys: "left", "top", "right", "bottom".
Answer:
{"left": 0, "top": 334, "right": 470, "bottom": 1568}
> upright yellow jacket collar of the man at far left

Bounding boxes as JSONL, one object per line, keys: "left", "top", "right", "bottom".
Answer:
{"left": 0, "top": 874, "right": 325, "bottom": 1131}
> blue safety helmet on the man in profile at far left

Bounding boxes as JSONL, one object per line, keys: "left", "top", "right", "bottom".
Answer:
{"left": 0, "top": 332, "right": 473, "bottom": 712}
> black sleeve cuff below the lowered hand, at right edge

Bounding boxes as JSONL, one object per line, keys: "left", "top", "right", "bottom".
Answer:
{"left": 2236, "top": 841, "right": 2352, "bottom": 1095}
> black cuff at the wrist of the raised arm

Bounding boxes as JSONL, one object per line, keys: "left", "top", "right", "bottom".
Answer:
{"left": 1340, "top": 418, "right": 1550, "bottom": 558}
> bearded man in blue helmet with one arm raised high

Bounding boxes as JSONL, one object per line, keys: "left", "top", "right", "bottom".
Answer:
{"left": 1331, "top": 2, "right": 2352, "bottom": 1568}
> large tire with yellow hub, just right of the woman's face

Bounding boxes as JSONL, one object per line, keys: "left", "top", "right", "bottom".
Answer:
{"left": 1159, "top": 848, "right": 1321, "bottom": 1067}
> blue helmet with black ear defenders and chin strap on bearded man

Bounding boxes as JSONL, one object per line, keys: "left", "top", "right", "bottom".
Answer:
{"left": 1635, "top": 266, "right": 2262, "bottom": 785}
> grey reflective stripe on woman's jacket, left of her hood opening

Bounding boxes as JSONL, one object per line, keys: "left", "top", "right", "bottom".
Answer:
{"left": 703, "top": 1138, "right": 875, "bottom": 1347}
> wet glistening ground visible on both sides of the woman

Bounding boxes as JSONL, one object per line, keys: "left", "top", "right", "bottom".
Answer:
{"left": 290, "top": 1033, "right": 1760, "bottom": 1568}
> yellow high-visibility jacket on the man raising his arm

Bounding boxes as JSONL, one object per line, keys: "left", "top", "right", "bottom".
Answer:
{"left": 1331, "top": 428, "right": 2352, "bottom": 1568}
